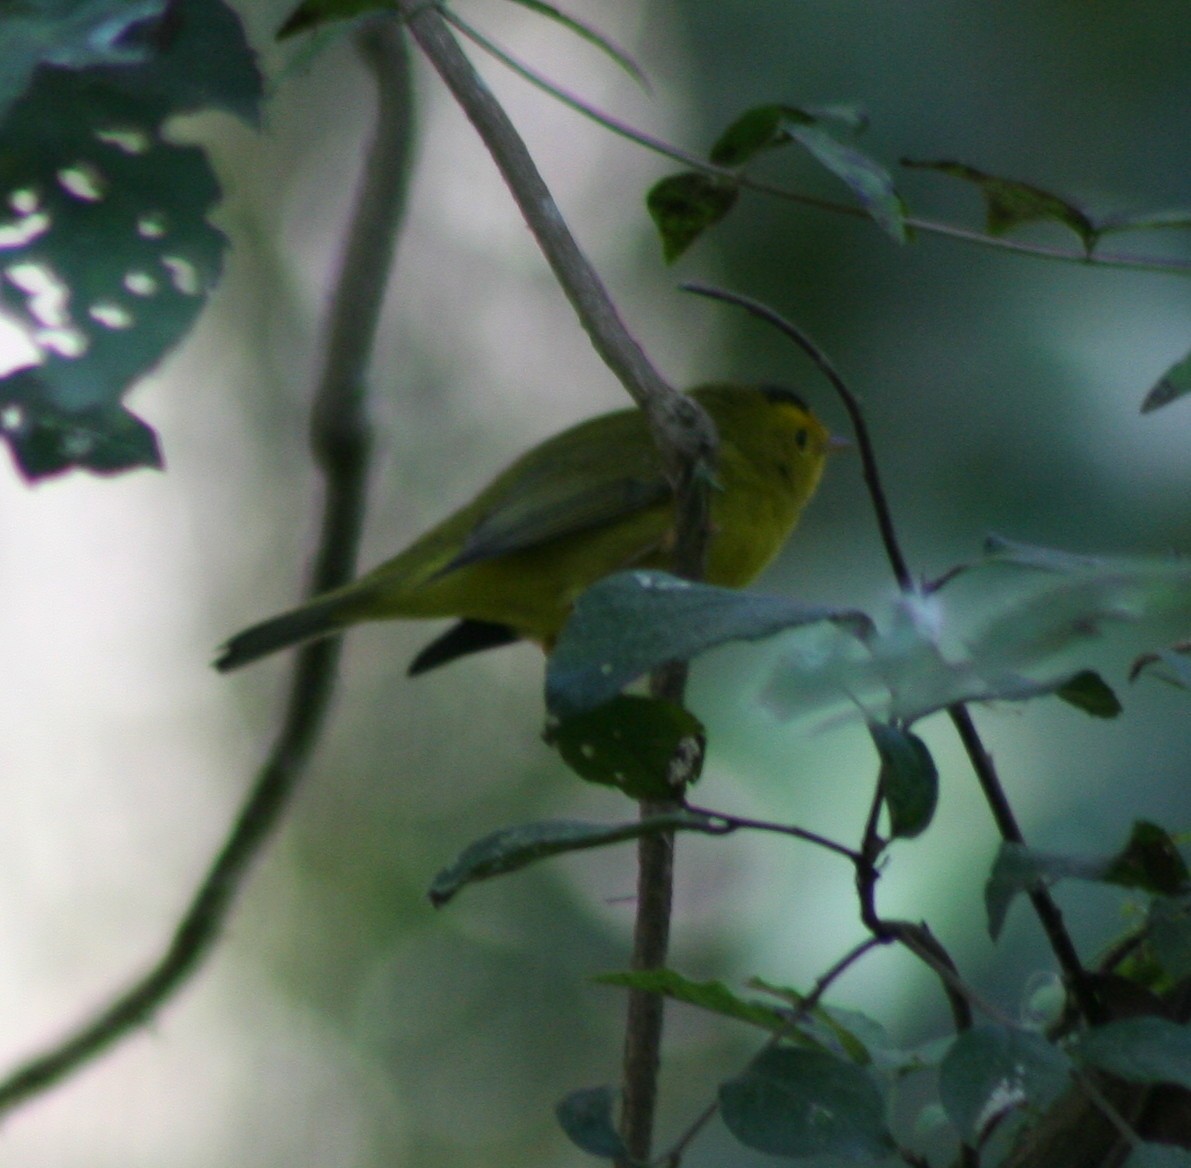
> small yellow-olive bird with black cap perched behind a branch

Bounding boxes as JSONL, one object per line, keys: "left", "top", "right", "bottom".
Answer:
{"left": 214, "top": 382, "right": 840, "bottom": 676}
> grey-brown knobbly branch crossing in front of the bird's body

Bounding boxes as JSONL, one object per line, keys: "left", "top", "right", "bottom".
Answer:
{"left": 397, "top": 0, "right": 717, "bottom": 1162}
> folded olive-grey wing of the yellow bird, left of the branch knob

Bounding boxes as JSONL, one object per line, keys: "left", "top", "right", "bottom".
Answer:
{"left": 442, "top": 411, "right": 671, "bottom": 573}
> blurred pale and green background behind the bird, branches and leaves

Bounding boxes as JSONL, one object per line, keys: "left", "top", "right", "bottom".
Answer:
{"left": 0, "top": 0, "right": 1191, "bottom": 1168}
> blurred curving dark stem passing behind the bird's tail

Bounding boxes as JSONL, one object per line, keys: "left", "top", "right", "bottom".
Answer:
{"left": 0, "top": 24, "right": 413, "bottom": 1112}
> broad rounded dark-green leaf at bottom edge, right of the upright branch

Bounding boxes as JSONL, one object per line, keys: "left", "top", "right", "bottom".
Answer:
{"left": 719, "top": 1047, "right": 893, "bottom": 1160}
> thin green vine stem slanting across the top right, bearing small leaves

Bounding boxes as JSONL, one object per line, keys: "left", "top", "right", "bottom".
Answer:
{"left": 443, "top": 10, "right": 1191, "bottom": 276}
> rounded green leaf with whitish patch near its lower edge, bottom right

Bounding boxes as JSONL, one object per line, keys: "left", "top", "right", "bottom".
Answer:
{"left": 939, "top": 1025, "right": 1071, "bottom": 1143}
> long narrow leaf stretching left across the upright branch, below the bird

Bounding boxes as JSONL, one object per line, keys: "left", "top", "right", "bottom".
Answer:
{"left": 429, "top": 811, "right": 722, "bottom": 908}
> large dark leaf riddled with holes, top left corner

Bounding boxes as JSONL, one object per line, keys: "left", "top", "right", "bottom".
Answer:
{"left": 0, "top": 0, "right": 261, "bottom": 477}
